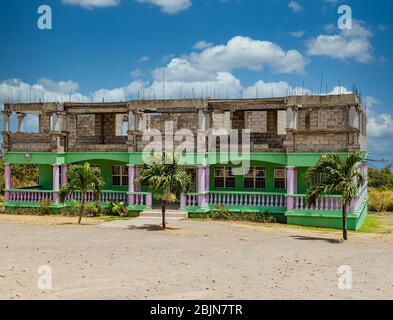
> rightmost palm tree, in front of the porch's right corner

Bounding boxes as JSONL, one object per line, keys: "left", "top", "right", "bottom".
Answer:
{"left": 305, "top": 152, "right": 367, "bottom": 240}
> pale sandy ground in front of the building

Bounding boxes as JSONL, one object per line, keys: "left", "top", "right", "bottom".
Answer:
{"left": 0, "top": 216, "right": 393, "bottom": 299}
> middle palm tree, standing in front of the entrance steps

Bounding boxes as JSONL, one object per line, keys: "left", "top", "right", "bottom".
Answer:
{"left": 135, "top": 154, "right": 191, "bottom": 230}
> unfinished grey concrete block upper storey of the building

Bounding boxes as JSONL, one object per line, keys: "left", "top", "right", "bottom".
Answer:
{"left": 4, "top": 95, "right": 367, "bottom": 152}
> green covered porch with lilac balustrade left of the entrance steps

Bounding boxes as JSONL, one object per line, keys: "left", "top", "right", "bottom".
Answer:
{"left": 4, "top": 161, "right": 153, "bottom": 211}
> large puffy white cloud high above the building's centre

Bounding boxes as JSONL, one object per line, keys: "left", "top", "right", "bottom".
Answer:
{"left": 154, "top": 36, "right": 306, "bottom": 81}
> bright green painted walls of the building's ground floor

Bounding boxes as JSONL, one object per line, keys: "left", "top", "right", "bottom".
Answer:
{"left": 4, "top": 152, "right": 367, "bottom": 230}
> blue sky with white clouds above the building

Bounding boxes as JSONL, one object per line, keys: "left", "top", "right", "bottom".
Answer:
{"left": 0, "top": 0, "right": 393, "bottom": 164}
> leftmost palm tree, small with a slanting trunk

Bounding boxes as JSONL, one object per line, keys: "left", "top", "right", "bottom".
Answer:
{"left": 59, "top": 162, "right": 104, "bottom": 224}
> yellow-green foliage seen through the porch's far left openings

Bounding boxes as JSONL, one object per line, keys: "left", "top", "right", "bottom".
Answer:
{"left": 0, "top": 161, "right": 38, "bottom": 194}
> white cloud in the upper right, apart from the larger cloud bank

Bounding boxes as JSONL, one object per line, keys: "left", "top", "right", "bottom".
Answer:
{"left": 307, "top": 20, "right": 373, "bottom": 63}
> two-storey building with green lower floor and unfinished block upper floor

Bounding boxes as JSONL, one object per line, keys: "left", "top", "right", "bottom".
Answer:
{"left": 3, "top": 94, "right": 368, "bottom": 230}
